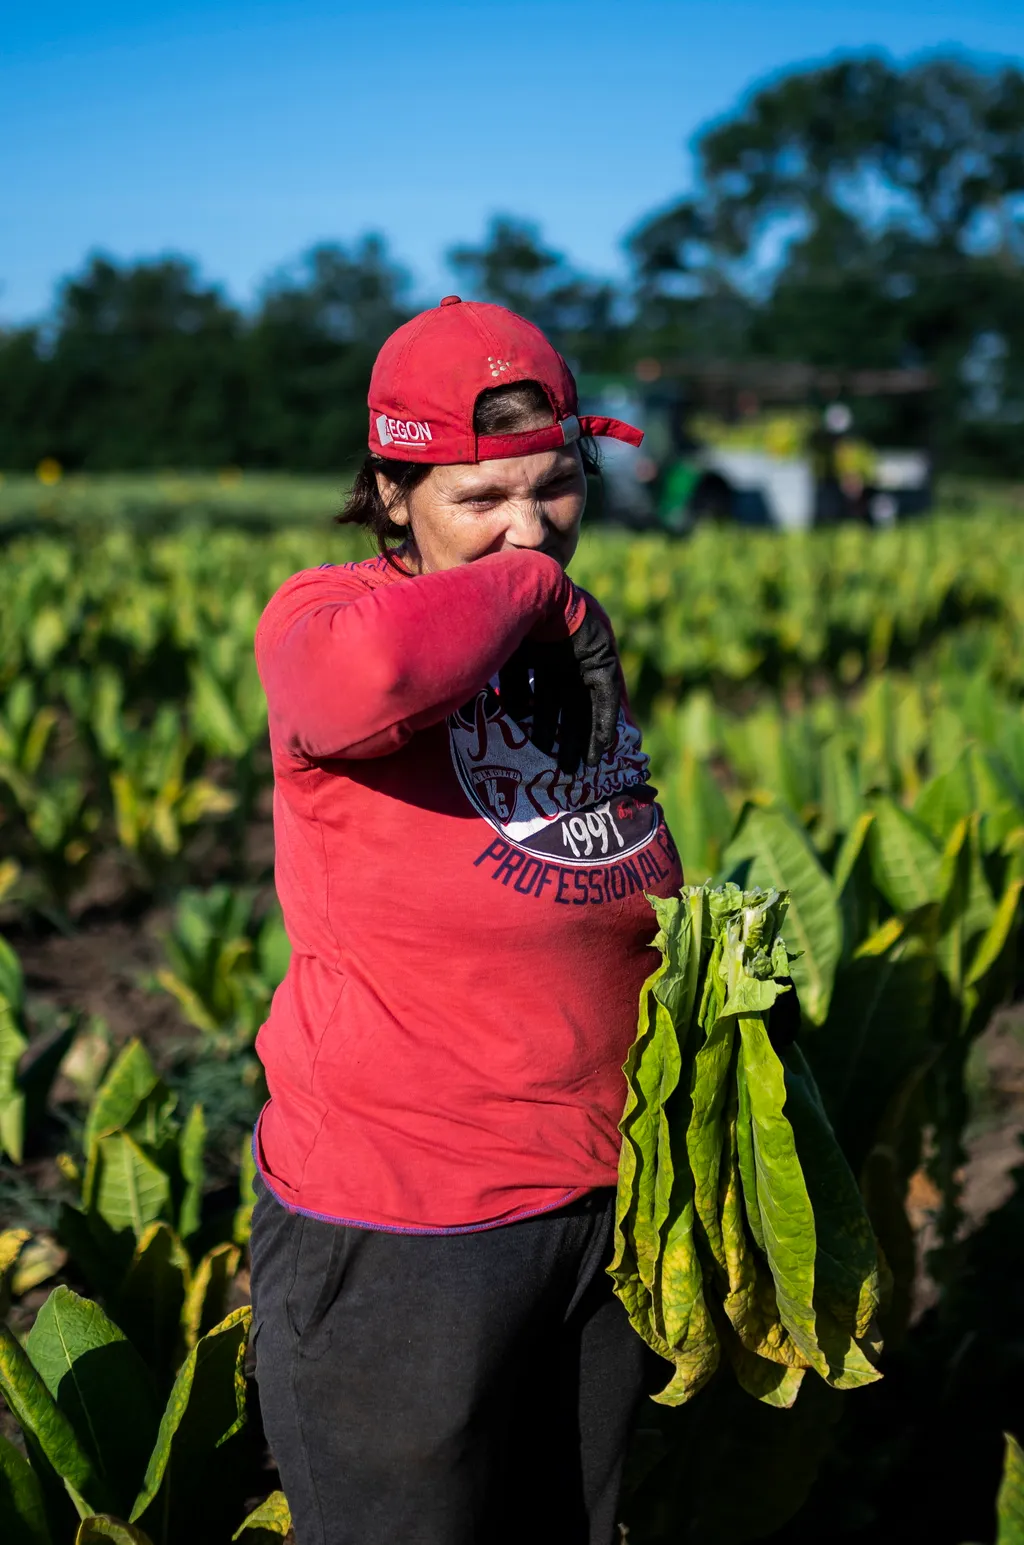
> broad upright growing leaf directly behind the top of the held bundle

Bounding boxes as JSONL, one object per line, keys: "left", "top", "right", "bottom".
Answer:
{"left": 724, "top": 806, "right": 842, "bottom": 1024}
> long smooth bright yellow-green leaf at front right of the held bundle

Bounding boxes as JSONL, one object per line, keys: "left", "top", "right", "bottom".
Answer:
{"left": 740, "top": 1015, "right": 828, "bottom": 1378}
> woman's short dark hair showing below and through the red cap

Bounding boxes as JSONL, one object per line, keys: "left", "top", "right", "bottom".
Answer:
{"left": 335, "top": 382, "right": 598, "bottom": 558}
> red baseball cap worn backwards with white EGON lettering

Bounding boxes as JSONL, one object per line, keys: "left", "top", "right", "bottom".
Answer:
{"left": 368, "top": 295, "right": 644, "bottom": 465}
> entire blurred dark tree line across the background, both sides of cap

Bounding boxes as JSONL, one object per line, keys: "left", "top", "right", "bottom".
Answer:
{"left": 0, "top": 54, "right": 1024, "bottom": 476}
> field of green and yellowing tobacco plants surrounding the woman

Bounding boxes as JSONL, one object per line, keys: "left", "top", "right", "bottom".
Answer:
{"left": 0, "top": 474, "right": 1024, "bottom": 1545}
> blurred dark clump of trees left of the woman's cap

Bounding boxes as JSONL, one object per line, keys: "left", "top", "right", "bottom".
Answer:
{"left": 0, "top": 236, "right": 408, "bottom": 471}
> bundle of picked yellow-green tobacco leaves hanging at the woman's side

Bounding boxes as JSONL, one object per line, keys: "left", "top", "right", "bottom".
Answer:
{"left": 609, "top": 884, "right": 883, "bottom": 1406}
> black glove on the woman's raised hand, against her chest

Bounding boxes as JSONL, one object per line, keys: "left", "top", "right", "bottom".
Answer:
{"left": 499, "top": 610, "right": 622, "bottom": 774}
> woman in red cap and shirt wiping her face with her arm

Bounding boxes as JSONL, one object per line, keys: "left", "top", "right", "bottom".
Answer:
{"left": 252, "top": 295, "right": 681, "bottom": 1545}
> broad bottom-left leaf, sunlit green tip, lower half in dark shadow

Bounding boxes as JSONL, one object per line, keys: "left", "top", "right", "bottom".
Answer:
{"left": 25, "top": 1287, "right": 158, "bottom": 1514}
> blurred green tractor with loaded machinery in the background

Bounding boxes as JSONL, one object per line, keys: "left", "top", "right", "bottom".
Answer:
{"left": 579, "top": 360, "right": 931, "bottom": 536}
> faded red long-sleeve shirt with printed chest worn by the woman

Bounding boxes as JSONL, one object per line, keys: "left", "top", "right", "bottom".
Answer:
{"left": 256, "top": 552, "right": 683, "bottom": 1231}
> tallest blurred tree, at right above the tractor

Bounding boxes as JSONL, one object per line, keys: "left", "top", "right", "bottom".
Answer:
{"left": 630, "top": 56, "right": 1024, "bottom": 467}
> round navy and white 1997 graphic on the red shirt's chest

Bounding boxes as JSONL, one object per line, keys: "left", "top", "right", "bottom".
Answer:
{"left": 448, "top": 688, "right": 658, "bottom": 865}
